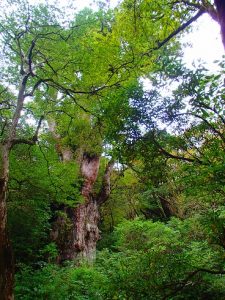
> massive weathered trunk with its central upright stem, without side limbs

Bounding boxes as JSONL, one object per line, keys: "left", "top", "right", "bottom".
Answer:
{"left": 52, "top": 153, "right": 100, "bottom": 263}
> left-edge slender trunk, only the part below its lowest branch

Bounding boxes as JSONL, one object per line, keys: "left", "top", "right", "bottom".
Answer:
{"left": 0, "top": 145, "right": 14, "bottom": 300}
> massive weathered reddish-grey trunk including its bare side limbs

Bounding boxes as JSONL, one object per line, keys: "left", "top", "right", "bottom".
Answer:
{"left": 48, "top": 115, "right": 113, "bottom": 263}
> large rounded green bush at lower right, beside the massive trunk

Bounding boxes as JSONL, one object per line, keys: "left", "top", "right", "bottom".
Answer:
{"left": 99, "top": 219, "right": 225, "bottom": 299}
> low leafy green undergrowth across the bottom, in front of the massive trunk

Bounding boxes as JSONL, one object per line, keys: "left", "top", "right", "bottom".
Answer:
{"left": 16, "top": 218, "right": 225, "bottom": 300}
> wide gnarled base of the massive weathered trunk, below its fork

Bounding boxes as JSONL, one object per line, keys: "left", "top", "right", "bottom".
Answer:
{"left": 51, "top": 200, "right": 99, "bottom": 263}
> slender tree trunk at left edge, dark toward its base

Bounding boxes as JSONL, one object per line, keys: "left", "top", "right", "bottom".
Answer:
{"left": 0, "top": 69, "right": 30, "bottom": 300}
